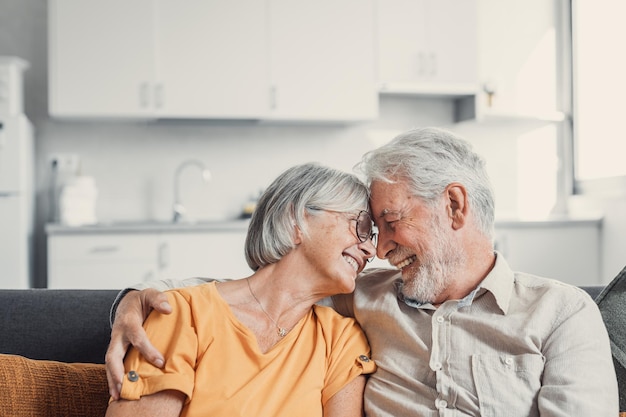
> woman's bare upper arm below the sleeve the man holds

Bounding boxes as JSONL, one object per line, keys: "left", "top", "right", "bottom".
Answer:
{"left": 106, "top": 390, "right": 185, "bottom": 417}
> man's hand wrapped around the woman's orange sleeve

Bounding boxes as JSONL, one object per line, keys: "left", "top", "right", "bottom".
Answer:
{"left": 105, "top": 288, "right": 172, "bottom": 400}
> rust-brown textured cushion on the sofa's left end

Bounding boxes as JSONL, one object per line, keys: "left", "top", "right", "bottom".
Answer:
{"left": 0, "top": 354, "right": 109, "bottom": 417}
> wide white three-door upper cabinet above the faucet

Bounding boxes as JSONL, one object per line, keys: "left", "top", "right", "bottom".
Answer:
{"left": 49, "top": 0, "right": 378, "bottom": 120}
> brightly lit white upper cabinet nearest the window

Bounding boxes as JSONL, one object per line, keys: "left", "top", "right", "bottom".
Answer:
{"left": 468, "top": 0, "right": 567, "bottom": 123}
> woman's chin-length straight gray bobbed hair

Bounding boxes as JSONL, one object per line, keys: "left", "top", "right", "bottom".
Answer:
{"left": 245, "top": 163, "right": 369, "bottom": 271}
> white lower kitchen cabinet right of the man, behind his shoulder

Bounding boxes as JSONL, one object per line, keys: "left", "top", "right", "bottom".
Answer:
{"left": 496, "top": 220, "right": 602, "bottom": 286}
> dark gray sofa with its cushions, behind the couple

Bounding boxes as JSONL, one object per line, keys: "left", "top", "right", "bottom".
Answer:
{"left": 0, "top": 276, "right": 626, "bottom": 417}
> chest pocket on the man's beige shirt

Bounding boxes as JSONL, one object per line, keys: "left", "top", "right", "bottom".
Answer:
{"left": 472, "top": 354, "right": 544, "bottom": 417}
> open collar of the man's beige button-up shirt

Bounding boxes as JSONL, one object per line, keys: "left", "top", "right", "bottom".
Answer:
{"left": 394, "top": 251, "right": 514, "bottom": 314}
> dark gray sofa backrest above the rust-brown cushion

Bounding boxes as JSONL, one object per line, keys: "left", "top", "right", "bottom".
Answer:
{"left": 0, "top": 289, "right": 118, "bottom": 363}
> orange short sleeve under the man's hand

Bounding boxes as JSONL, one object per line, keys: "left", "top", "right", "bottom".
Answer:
{"left": 121, "top": 291, "right": 198, "bottom": 401}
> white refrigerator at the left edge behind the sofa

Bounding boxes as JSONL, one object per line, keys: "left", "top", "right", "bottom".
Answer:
{"left": 0, "top": 57, "right": 35, "bottom": 289}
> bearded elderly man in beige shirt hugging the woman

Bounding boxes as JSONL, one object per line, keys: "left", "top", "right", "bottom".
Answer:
{"left": 107, "top": 128, "right": 618, "bottom": 417}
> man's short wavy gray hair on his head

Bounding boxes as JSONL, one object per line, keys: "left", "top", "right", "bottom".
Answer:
{"left": 356, "top": 128, "right": 495, "bottom": 239}
